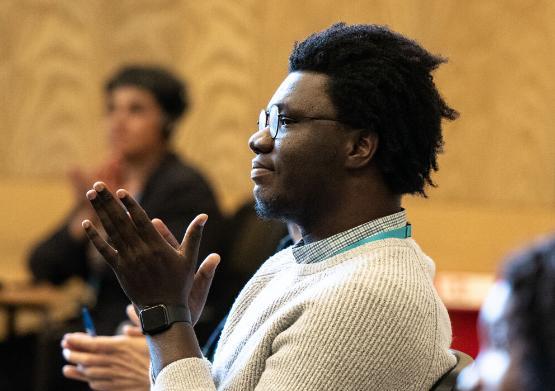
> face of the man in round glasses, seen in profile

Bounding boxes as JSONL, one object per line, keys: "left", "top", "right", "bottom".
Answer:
{"left": 249, "top": 72, "right": 345, "bottom": 225}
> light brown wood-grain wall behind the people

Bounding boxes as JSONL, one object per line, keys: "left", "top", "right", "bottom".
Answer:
{"left": 0, "top": 0, "right": 555, "bottom": 279}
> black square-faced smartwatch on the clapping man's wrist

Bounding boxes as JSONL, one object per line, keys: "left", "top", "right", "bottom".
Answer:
{"left": 139, "top": 304, "right": 191, "bottom": 335}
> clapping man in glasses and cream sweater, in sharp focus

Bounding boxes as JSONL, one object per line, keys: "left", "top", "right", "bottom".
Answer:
{"left": 64, "top": 24, "right": 457, "bottom": 390}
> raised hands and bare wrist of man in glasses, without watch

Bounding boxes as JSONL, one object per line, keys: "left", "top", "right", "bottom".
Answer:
{"left": 83, "top": 182, "right": 220, "bottom": 376}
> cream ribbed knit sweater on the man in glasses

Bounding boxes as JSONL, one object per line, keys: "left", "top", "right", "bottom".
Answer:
{"left": 153, "top": 239, "right": 456, "bottom": 391}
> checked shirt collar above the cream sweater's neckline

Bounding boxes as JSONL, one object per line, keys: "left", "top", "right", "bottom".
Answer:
{"left": 292, "top": 209, "right": 407, "bottom": 263}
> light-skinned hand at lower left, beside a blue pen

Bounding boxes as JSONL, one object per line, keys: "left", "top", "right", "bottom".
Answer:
{"left": 62, "top": 333, "right": 150, "bottom": 391}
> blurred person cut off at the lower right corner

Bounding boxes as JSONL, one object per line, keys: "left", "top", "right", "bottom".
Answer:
{"left": 458, "top": 238, "right": 555, "bottom": 391}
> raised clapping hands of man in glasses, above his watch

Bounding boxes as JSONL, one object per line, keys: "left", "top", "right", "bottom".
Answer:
{"left": 83, "top": 182, "right": 219, "bottom": 312}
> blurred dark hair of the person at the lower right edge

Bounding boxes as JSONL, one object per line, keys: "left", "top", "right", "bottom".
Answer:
{"left": 503, "top": 238, "right": 555, "bottom": 391}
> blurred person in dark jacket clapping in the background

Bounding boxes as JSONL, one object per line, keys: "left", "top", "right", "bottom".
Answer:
{"left": 25, "top": 65, "right": 221, "bottom": 391}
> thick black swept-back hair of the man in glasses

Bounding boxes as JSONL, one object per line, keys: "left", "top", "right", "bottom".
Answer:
{"left": 289, "top": 23, "right": 458, "bottom": 196}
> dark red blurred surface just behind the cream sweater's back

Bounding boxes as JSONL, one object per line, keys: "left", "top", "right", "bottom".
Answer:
{"left": 447, "top": 309, "right": 479, "bottom": 358}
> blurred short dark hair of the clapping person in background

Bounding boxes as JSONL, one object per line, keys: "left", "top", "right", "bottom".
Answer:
{"left": 105, "top": 65, "right": 189, "bottom": 139}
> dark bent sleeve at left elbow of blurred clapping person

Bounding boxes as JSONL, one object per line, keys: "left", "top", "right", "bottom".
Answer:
{"left": 28, "top": 225, "right": 88, "bottom": 284}
